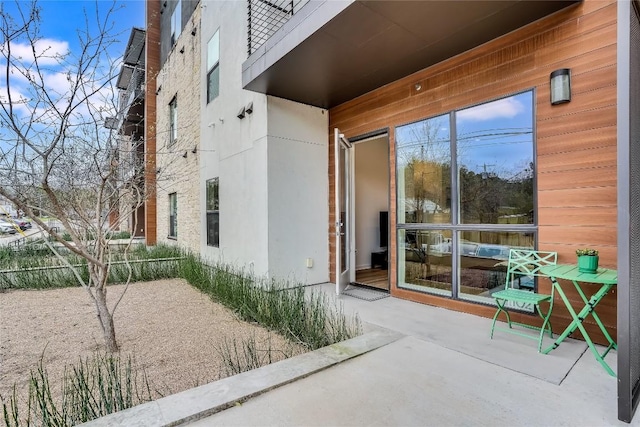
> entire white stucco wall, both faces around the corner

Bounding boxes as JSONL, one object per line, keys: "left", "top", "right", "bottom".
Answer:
{"left": 199, "top": 1, "right": 329, "bottom": 283}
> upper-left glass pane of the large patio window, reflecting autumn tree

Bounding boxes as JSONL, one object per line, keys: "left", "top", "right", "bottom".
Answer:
{"left": 395, "top": 115, "right": 451, "bottom": 224}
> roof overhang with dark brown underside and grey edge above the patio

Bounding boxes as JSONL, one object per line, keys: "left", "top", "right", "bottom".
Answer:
{"left": 242, "top": 0, "right": 580, "bottom": 108}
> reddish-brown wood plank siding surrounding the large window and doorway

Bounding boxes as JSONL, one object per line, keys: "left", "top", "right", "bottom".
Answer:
{"left": 328, "top": 0, "right": 617, "bottom": 341}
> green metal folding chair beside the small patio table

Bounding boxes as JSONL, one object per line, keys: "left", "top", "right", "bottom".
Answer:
{"left": 491, "top": 249, "right": 558, "bottom": 352}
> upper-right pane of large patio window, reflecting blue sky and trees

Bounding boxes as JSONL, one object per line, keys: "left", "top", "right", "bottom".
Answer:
{"left": 456, "top": 92, "right": 534, "bottom": 224}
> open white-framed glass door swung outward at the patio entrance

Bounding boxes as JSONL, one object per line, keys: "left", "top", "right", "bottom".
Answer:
{"left": 334, "top": 128, "right": 355, "bottom": 295}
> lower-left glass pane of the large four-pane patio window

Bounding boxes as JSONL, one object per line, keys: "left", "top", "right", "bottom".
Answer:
{"left": 398, "top": 229, "right": 454, "bottom": 296}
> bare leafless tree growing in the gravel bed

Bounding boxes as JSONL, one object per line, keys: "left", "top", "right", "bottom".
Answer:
{"left": 0, "top": 1, "right": 145, "bottom": 352}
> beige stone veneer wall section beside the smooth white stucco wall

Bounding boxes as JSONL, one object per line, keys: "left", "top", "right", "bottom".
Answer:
{"left": 152, "top": 7, "right": 201, "bottom": 252}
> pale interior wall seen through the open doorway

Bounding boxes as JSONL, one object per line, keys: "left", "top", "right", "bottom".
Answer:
{"left": 354, "top": 135, "right": 389, "bottom": 269}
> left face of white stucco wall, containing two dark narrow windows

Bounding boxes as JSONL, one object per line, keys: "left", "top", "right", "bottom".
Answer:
{"left": 199, "top": 1, "right": 268, "bottom": 274}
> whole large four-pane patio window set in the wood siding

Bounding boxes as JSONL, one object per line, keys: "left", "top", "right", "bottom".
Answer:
{"left": 395, "top": 91, "right": 537, "bottom": 304}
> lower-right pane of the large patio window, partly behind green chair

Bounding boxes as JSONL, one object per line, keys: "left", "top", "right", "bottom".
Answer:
{"left": 458, "top": 231, "right": 534, "bottom": 304}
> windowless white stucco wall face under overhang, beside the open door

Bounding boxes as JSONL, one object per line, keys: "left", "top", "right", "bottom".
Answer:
{"left": 268, "top": 97, "right": 329, "bottom": 283}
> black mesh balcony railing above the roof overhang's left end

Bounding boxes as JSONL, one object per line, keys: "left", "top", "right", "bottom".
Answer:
{"left": 247, "top": 0, "right": 309, "bottom": 55}
